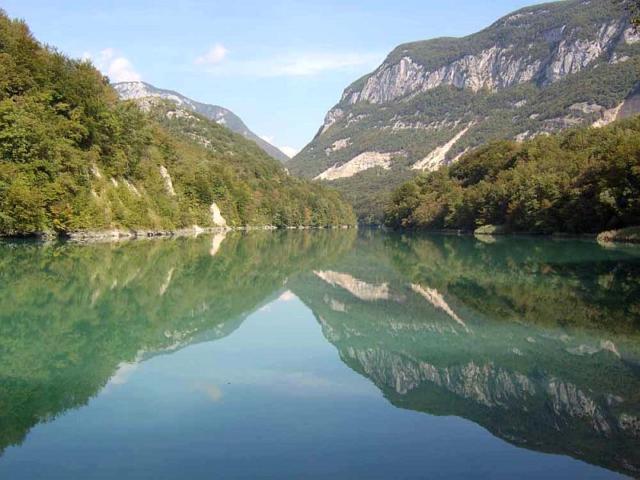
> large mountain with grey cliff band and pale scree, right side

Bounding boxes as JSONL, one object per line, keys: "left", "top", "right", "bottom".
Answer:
{"left": 287, "top": 0, "right": 640, "bottom": 219}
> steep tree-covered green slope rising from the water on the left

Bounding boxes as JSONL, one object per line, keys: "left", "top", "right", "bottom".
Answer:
{"left": 0, "top": 14, "right": 353, "bottom": 235}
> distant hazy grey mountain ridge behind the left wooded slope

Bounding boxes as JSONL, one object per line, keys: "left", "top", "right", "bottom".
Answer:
{"left": 113, "top": 82, "right": 289, "bottom": 163}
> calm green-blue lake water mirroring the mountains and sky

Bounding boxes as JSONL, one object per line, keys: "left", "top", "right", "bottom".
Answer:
{"left": 0, "top": 231, "right": 640, "bottom": 480}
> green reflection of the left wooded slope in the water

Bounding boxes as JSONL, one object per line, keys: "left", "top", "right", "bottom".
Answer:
{"left": 0, "top": 231, "right": 355, "bottom": 452}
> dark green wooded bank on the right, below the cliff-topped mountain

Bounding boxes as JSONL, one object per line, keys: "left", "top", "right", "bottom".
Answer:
{"left": 385, "top": 117, "right": 640, "bottom": 233}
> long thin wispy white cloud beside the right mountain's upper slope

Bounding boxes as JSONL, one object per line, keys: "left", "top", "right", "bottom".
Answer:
{"left": 195, "top": 52, "right": 383, "bottom": 77}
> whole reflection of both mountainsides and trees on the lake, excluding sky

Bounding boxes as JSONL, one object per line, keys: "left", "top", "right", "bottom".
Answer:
{"left": 0, "top": 231, "right": 640, "bottom": 475}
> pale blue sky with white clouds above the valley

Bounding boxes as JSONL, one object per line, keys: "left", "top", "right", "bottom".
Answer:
{"left": 2, "top": 0, "right": 535, "bottom": 156}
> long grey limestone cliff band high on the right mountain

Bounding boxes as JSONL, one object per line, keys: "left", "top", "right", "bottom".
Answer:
{"left": 323, "top": 19, "right": 624, "bottom": 130}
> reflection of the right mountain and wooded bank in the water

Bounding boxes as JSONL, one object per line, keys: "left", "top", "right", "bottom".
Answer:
{"left": 293, "top": 235, "right": 640, "bottom": 475}
